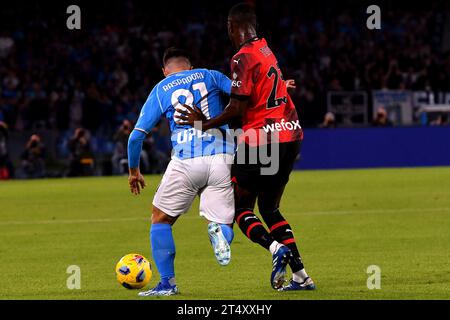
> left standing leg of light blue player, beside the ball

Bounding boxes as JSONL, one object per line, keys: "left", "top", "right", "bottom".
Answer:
{"left": 139, "top": 160, "right": 197, "bottom": 296}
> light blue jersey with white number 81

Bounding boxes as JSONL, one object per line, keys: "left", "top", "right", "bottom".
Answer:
{"left": 135, "top": 69, "right": 234, "bottom": 159}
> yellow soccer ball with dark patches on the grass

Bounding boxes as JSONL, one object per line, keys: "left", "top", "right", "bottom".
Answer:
{"left": 116, "top": 253, "right": 152, "bottom": 289}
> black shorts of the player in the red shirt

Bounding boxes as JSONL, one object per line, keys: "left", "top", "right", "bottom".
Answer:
{"left": 231, "top": 141, "right": 301, "bottom": 192}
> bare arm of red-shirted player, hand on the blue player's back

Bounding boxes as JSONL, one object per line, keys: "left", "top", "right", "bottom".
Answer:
{"left": 175, "top": 97, "right": 248, "bottom": 131}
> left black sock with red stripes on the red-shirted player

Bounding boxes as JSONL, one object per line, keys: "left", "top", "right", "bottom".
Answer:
{"left": 235, "top": 209, "right": 274, "bottom": 250}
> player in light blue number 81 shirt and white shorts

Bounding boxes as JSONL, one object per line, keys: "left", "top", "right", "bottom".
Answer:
{"left": 128, "top": 48, "right": 235, "bottom": 296}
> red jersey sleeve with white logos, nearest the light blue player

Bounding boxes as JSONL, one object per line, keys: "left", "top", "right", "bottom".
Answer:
{"left": 231, "top": 53, "right": 258, "bottom": 98}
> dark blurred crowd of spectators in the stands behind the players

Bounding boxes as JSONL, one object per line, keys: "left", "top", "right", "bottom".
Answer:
{"left": 0, "top": 1, "right": 450, "bottom": 178}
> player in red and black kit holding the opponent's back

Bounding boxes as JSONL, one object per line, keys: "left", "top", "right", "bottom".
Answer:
{"left": 174, "top": 3, "right": 315, "bottom": 291}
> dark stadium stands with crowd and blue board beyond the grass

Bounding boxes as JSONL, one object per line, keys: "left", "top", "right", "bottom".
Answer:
{"left": 0, "top": 1, "right": 450, "bottom": 178}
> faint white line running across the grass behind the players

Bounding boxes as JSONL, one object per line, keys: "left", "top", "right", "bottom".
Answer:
{"left": 0, "top": 207, "right": 450, "bottom": 226}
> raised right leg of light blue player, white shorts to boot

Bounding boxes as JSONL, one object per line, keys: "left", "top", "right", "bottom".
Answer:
{"left": 200, "top": 154, "right": 234, "bottom": 265}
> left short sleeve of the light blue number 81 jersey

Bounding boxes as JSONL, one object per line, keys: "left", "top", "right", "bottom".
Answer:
{"left": 134, "top": 86, "right": 164, "bottom": 134}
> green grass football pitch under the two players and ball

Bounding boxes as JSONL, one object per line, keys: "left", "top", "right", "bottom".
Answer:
{"left": 0, "top": 168, "right": 450, "bottom": 300}
